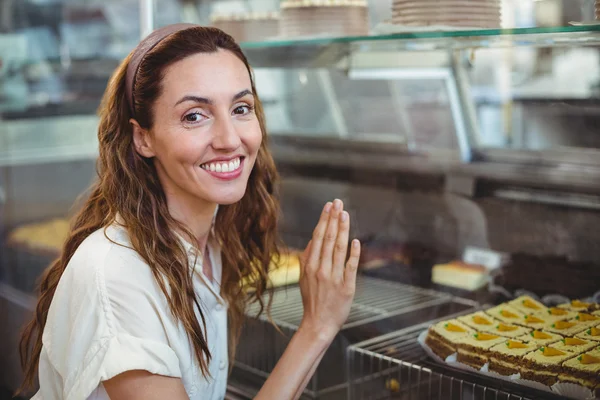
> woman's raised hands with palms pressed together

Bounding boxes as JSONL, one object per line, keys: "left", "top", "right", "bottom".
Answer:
{"left": 300, "top": 199, "right": 360, "bottom": 340}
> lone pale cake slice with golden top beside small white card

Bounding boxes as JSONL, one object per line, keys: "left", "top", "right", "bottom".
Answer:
{"left": 431, "top": 261, "right": 489, "bottom": 291}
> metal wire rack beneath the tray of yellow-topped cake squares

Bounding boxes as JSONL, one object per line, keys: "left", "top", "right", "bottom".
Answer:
{"left": 346, "top": 317, "right": 560, "bottom": 400}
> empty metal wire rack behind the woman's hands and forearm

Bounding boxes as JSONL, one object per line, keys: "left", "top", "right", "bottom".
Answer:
{"left": 235, "top": 277, "right": 476, "bottom": 399}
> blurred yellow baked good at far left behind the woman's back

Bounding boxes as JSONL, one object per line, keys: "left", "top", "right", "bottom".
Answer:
{"left": 7, "top": 218, "right": 69, "bottom": 257}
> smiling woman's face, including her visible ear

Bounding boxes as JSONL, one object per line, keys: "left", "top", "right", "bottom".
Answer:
{"left": 134, "top": 50, "right": 262, "bottom": 209}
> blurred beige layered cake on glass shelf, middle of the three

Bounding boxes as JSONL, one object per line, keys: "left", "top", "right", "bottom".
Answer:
{"left": 280, "top": 0, "right": 369, "bottom": 37}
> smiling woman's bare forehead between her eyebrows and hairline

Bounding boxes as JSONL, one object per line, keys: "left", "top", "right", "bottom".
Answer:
{"left": 161, "top": 49, "right": 251, "bottom": 101}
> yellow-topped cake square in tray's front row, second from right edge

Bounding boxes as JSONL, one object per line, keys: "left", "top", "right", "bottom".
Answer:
{"left": 520, "top": 346, "right": 577, "bottom": 386}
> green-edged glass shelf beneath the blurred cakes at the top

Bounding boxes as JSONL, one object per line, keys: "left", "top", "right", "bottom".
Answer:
{"left": 241, "top": 24, "right": 600, "bottom": 68}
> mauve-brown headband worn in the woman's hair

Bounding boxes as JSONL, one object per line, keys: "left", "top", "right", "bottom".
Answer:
{"left": 125, "top": 23, "right": 200, "bottom": 117}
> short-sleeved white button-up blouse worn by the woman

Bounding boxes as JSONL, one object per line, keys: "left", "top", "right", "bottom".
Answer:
{"left": 33, "top": 224, "right": 228, "bottom": 400}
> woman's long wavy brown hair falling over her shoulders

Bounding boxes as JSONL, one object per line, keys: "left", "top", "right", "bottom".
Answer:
{"left": 19, "top": 27, "right": 279, "bottom": 392}
